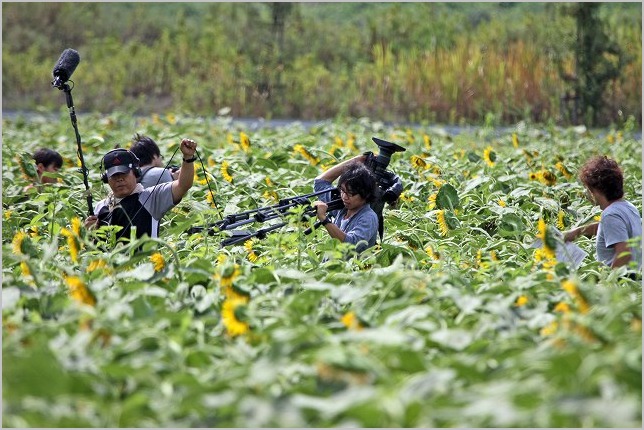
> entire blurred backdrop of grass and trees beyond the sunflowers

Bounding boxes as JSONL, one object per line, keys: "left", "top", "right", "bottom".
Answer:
{"left": 2, "top": 2, "right": 642, "bottom": 128}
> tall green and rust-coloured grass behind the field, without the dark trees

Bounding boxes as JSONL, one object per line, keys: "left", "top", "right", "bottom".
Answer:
{"left": 2, "top": 4, "right": 642, "bottom": 124}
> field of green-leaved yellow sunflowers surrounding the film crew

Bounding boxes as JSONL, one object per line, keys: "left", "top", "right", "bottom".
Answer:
{"left": 2, "top": 113, "right": 642, "bottom": 428}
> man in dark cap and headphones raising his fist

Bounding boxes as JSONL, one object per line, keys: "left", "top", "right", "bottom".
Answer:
{"left": 85, "top": 139, "right": 197, "bottom": 239}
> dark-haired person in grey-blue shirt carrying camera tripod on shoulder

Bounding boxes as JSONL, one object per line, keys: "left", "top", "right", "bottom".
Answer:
{"left": 313, "top": 155, "right": 378, "bottom": 252}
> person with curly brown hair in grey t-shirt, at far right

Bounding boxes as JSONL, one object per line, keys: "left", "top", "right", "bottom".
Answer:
{"left": 564, "top": 156, "right": 642, "bottom": 270}
